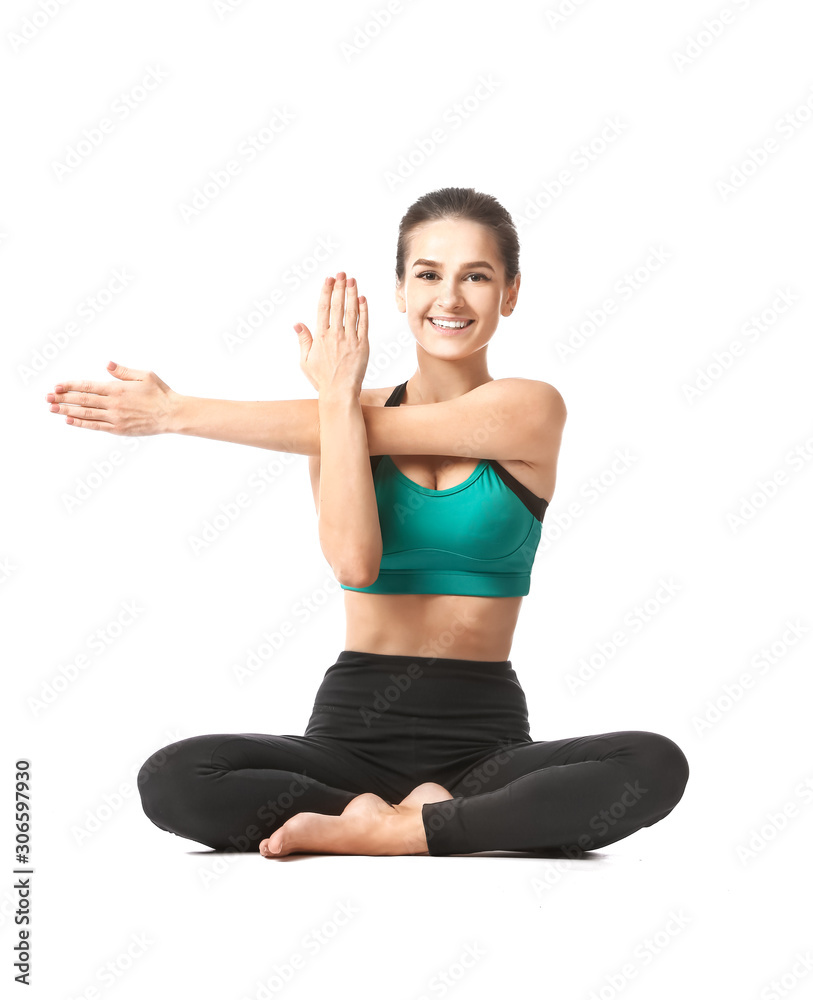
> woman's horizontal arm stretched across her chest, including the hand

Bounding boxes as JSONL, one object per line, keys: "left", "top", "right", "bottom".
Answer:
{"left": 46, "top": 361, "right": 566, "bottom": 464}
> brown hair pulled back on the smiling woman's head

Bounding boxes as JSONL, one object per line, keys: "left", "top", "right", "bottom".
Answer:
{"left": 395, "top": 187, "right": 519, "bottom": 285}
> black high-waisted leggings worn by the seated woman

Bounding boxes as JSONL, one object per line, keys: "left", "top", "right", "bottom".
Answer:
{"left": 138, "top": 650, "right": 689, "bottom": 857}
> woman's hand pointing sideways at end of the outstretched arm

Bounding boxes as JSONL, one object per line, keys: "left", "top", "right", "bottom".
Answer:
{"left": 45, "top": 361, "right": 180, "bottom": 436}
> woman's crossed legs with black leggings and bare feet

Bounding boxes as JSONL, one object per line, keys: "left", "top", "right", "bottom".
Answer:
{"left": 138, "top": 730, "right": 689, "bottom": 857}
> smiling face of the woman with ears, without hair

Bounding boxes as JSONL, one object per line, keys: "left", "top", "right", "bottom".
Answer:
{"left": 395, "top": 219, "right": 520, "bottom": 357}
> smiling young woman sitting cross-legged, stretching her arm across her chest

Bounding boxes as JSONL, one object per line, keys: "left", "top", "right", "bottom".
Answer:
{"left": 47, "top": 187, "right": 689, "bottom": 858}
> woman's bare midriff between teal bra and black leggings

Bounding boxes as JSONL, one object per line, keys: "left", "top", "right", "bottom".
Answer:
{"left": 344, "top": 590, "right": 522, "bottom": 661}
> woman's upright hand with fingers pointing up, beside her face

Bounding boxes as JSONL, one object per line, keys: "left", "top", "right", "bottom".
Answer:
{"left": 294, "top": 271, "right": 370, "bottom": 396}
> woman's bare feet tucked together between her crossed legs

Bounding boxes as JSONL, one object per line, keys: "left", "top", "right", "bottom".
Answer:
{"left": 260, "top": 781, "right": 454, "bottom": 858}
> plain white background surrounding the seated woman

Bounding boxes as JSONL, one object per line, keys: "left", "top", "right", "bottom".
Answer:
{"left": 0, "top": 0, "right": 813, "bottom": 1000}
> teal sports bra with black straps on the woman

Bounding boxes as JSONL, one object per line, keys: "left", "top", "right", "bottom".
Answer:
{"left": 340, "top": 379, "right": 548, "bottom": 597}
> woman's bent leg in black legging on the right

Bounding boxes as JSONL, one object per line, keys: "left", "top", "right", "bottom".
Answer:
{"left": 422, "top": 730, "right": 689, "bottom": 857}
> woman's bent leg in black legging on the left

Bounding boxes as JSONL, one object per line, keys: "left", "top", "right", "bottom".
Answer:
{"left": 138, "top": 733, "right": 380, "bottom": 851}
